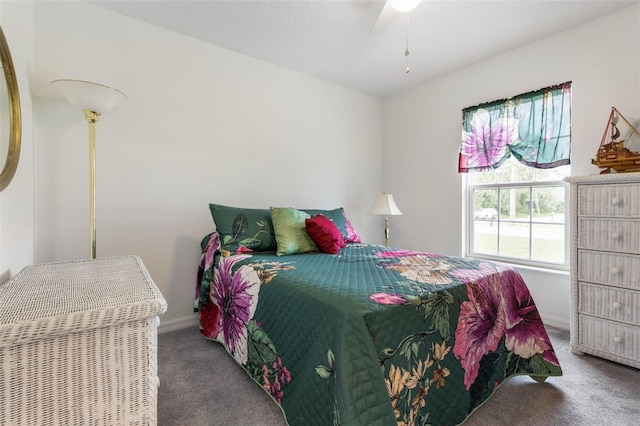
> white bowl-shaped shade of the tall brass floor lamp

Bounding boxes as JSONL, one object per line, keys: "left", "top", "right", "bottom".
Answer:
{"left": 51, "top": 80, "right": 127, "bottom": 113}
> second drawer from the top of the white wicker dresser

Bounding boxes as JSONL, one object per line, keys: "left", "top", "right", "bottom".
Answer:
{"left": 578, "top": 217, "right": 640, "bottom": 253}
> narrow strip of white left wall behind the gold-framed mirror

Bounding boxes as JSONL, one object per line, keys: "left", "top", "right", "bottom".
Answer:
{"left": 0, "top": 1, "right": 35, "bottom": 284}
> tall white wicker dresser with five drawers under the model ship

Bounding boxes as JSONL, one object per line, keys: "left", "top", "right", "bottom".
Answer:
{"left": 567, "top": 173, "right": 640, "bottom": 368}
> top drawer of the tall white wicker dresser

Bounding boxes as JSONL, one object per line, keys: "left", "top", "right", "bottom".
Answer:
{"left": 578, "top": 184, "right": 640, "bottom": 217}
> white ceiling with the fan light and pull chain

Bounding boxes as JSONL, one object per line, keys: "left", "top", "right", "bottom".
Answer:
{"left": 88, "top": 0, "right": 638, "bottom": 97}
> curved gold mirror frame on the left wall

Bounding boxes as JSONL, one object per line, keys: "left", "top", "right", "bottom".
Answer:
{"left": 0, "top": 27, "right": 22, "bottom": 191}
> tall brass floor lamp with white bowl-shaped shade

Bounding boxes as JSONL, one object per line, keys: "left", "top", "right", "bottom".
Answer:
{"left": 51, "top": 80, "right": 127, "bottom": 259}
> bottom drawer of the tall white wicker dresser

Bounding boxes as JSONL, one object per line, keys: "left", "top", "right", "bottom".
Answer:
{"left": 578, "top": 315, "right": 640, "bottom": 361}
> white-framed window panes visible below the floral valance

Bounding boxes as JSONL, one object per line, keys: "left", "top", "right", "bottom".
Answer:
{"left": 467, "top": 157, "right": 570, "bottom": 268}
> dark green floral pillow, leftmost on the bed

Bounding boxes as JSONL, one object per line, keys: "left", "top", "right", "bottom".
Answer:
{"left": 209, "top": 204, "right": 276, "bottom": 254}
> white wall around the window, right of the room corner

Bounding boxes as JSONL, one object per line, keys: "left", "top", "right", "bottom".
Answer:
{"left": 383, "top": 5, "right": 640, "bottom": 328}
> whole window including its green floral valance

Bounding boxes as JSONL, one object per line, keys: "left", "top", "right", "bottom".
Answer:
{"left": 458, "top": 82, "right": 571, "bottom": 269}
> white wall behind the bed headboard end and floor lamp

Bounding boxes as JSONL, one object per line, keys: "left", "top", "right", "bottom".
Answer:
{"left": 35, "top": 2, "right": 382, "bottom": 327}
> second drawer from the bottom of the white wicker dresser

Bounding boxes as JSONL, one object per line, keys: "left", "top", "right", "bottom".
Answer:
{"left": 578, "top": 282, "right": 640, "bottom": 326}
